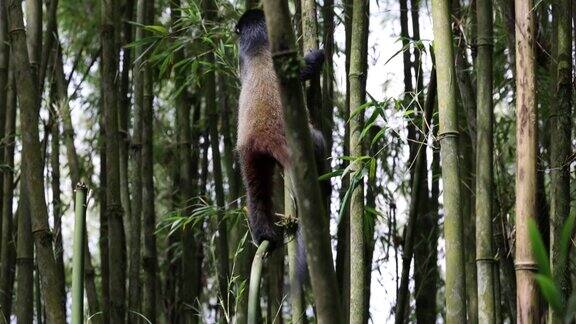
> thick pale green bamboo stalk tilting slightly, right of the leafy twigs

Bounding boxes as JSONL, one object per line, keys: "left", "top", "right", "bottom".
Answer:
{"left": 432, "top": 0, "right": 466, "bottom": 324}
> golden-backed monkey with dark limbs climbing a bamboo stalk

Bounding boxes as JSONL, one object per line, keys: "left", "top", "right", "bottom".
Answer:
{"left": 235, "top": 9, "right": 326, "bottom": 251}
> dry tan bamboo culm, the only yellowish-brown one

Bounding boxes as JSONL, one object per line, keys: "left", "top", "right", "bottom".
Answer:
{"left": 515, "top": 0, "right": 539, "bottom": 323}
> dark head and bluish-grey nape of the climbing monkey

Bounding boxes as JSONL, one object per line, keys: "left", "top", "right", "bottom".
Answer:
{"left": 235, "top": 9, "right": 268, "bottom": 57}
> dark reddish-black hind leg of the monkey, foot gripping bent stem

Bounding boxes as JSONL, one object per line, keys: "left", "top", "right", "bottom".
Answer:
{"left": 242, "top": 152, "right": 283, "bottom": 247}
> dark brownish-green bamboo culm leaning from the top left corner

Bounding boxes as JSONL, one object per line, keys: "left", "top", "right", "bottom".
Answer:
{"left": 2, "top": 0, "right": 66, "bottom": 323}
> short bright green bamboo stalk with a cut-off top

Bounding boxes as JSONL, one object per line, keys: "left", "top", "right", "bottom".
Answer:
{"left": 72, "top": 183, "right": 88, "bottom": 324}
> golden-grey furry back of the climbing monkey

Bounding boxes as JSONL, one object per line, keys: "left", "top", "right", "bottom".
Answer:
{"left": 237, "top": 51, "right": 286, "bottom": 162}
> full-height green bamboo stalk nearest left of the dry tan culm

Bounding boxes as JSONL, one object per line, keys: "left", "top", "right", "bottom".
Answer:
{"left": 476, "top": 0, "right": 496, "bottom": 323}
